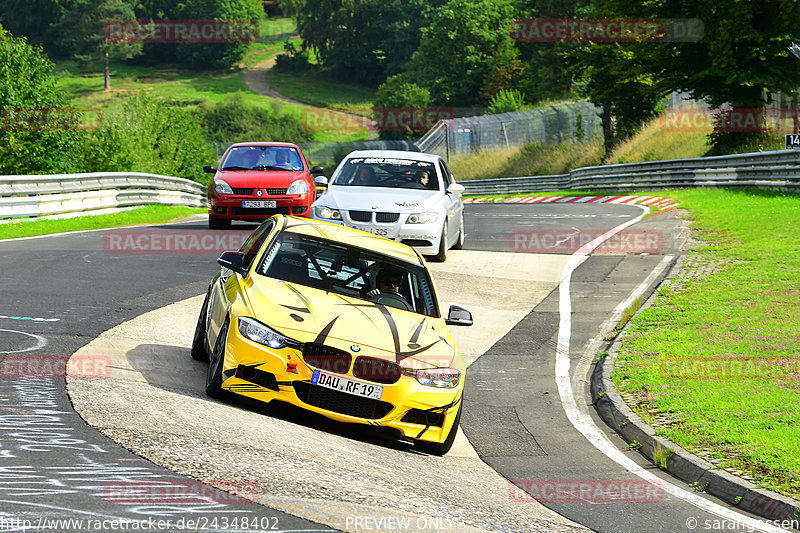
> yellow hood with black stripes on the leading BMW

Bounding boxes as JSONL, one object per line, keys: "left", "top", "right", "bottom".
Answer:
{"left": 246, "top": 276, "right": 457, "bottom": 369}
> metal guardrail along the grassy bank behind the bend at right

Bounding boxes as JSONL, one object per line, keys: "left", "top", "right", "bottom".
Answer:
{"left": 460, "top": 150, "right": 800, "bottom": 195}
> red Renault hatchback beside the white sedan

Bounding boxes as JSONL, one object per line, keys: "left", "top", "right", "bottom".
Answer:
{"left": 203, "top": 142, "right": 323, "bottom": 229}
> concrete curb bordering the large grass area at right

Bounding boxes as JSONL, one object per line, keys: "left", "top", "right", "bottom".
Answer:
{"left": 590, "top": 258, "right": 800, "bottom": 528}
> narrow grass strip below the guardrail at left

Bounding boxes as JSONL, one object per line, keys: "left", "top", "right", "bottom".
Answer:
{"left": 0, "top": 205, "right": 206, "bottom": 240}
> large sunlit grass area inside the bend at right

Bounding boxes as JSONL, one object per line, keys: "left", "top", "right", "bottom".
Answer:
{"left": 614, "top": 190, "right": 800, "bottom": 498}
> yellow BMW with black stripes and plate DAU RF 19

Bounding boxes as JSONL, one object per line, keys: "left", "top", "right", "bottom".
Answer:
{"left": 192, "top": 215, "right": 472, "bottom": 455}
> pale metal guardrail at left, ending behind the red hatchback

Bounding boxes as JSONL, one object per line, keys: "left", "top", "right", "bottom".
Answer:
{"left": 0, "top": 172, "right": 206, "bottom": 219}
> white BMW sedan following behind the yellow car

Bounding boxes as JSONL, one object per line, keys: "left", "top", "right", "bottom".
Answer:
{"left": 311, "top": 150, "right": 464, "bottom": 261}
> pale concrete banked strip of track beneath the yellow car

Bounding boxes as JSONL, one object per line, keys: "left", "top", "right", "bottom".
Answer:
{"left": 67, "top": 251, "right": 586, "bottom": 532}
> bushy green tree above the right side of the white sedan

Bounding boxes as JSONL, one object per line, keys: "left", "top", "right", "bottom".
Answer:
{"left": 410, "top": 0, "right": 514, "bottom": 106}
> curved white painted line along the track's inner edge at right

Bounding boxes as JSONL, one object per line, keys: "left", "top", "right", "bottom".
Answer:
{"left": 556, "top": 204, "right": 783, "bottom": 532}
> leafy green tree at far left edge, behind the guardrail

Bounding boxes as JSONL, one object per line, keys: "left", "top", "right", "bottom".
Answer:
{"left": 0, "top": 26, "right": 80, "bottom": 174}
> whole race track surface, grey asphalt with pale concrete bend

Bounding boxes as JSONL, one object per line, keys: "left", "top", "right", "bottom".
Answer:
{"left": 0, "top": 204, "right": 780, "bottom": 532}
